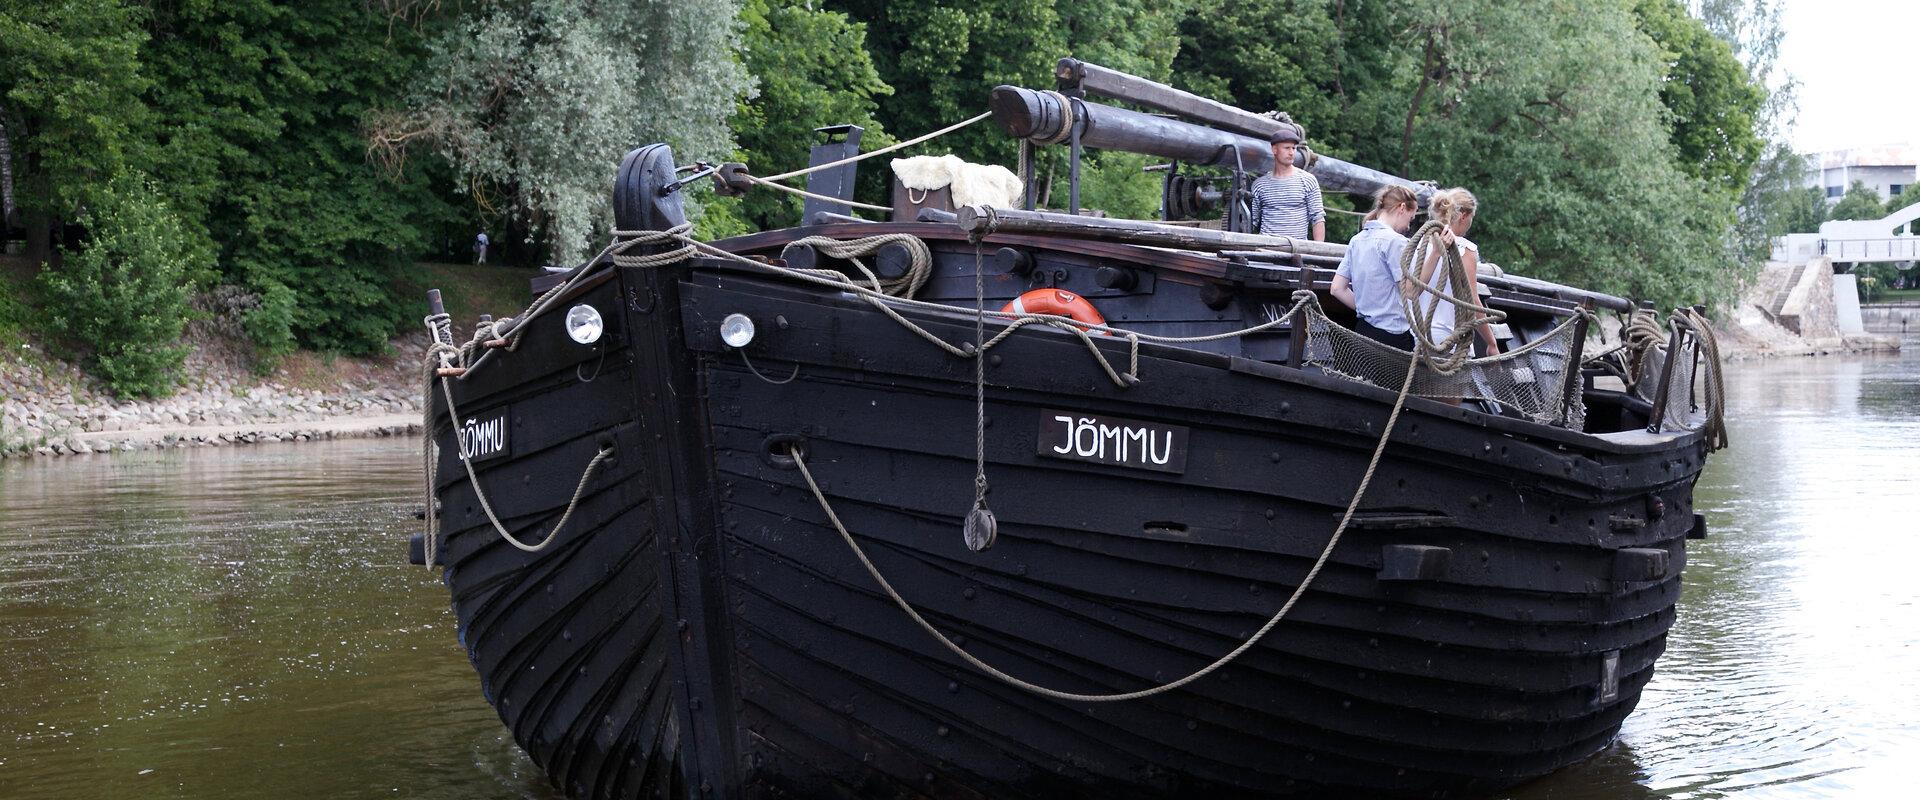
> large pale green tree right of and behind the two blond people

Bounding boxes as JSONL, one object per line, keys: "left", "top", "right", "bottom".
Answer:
{"left": 1386, "top": 0, "right": 1738, "bottom": 305}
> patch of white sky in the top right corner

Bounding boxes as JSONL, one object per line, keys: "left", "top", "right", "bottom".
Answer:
{"left": 1780, "top": 0, "right": 1920, "bottom": 153}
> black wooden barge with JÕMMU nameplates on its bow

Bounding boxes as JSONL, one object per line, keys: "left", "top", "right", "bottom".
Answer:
{"left": 417, "top": 62, "right": 1707, "bottom": 798}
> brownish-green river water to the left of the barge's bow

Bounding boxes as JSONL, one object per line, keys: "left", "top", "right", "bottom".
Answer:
{"left": 0, "top": 441, "right": 549, "bottom": 798}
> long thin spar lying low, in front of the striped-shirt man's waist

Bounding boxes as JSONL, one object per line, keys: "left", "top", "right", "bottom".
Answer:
{"left": 954, "top": 205, "right": 1346, "bottom": 259}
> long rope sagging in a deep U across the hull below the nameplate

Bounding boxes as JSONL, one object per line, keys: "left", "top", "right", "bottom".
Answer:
{"left": 793, "top": 333, "right": 1419, "bottom": 702}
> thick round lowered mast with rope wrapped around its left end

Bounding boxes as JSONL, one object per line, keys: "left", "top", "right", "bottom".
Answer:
{"left": 989, "top": 86, "right": 1434, "bottom": 205}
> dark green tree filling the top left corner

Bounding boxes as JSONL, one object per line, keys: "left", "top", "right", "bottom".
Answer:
{"left": 0, "top": 0, "right": 148, "bottom": 261}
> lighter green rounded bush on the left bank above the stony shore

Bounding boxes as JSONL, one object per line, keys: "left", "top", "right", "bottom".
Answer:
{"left": 40, "top": 175, "right": 198, "bottom": 397}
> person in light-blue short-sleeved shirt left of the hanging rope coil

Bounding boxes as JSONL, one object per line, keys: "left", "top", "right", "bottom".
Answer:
{"left": 1332, "top": 186, "right": 1421, "bottom": 351}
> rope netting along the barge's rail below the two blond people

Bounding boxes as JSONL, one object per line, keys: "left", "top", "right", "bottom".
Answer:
{"left": 1302, "top": 303, "right": 1586, "bottom": 430}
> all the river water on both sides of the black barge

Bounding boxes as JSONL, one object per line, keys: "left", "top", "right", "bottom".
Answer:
{"left": 0, "top": 341, "right": 1920, "bottom": 800}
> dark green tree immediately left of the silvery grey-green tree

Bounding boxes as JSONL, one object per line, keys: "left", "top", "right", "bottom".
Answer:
{"left": 144, "top": 0, "right": 451, "bottom": 354}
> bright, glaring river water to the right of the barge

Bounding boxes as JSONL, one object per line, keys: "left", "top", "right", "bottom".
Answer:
{"left": 1513, "top": 335, "right": 1920, "bottom": 798}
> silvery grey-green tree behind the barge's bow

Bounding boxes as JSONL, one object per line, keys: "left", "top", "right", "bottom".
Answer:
{"left": 371, "top": 0, "right": 751, "bottom": 263}
